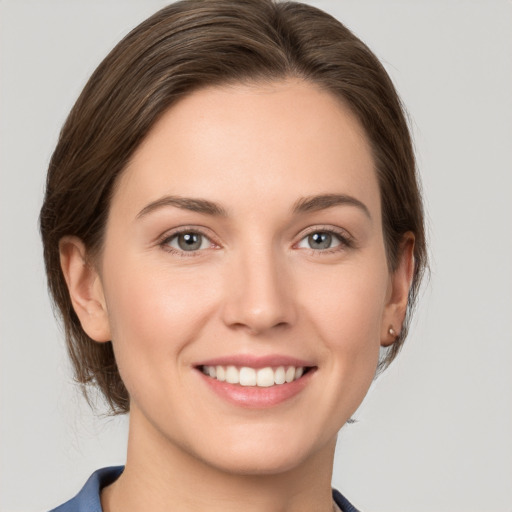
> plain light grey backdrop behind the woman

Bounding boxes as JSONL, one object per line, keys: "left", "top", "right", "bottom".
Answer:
{"left": 0, "top": 0, "right": 512, "bottom": 512}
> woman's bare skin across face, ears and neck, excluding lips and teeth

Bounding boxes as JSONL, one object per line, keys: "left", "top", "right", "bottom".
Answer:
{"left": 61, "top": 79, "right": 413, "bottom": 512}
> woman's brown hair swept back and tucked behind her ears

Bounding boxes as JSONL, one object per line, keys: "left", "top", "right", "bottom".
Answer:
{"left": 40, "top": 0, "right": 426, "bottom": 413}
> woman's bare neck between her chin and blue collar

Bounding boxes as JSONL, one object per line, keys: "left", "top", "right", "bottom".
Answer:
{"left": 101, "top": 412, "right": 336, "bottom": 512}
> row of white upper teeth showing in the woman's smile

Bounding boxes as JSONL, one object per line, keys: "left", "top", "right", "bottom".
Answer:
{"left": 202, "top": 366, "right": 304, "bottom": 388}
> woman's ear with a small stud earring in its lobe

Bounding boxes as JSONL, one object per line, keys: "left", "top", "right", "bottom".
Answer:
{"left": 380, "top": 232, "right": 414, "bottom": 347}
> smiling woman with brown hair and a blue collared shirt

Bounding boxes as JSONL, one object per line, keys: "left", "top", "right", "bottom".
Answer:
{"left": 41, "top": 0, "right": 426, "bottom": 512}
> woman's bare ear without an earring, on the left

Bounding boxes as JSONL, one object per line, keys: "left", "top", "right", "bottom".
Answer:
{"left": 59, "top": 236, "right": 111, "bottom": 342}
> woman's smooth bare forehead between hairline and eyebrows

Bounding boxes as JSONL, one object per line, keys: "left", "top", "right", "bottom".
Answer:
{"left": 112, "top": 79, "right": 380, "bottom": 219}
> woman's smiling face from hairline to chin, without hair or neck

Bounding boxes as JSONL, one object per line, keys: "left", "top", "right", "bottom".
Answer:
{"left": 72, "top": 80, "right": 410, "bottom": 473}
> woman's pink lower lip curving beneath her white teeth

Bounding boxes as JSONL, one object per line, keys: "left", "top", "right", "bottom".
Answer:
{"left": 198, "top": 369, "right": 315, "bottom": 409}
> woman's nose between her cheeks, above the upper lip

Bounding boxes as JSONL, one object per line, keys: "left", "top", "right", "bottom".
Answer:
{"left": 222, "top": 248, "right": 296, "bottom": 335}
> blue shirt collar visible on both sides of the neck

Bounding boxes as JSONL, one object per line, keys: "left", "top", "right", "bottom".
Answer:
{"left": 50, "top": 466, "right": 358, "bottom": 512}
